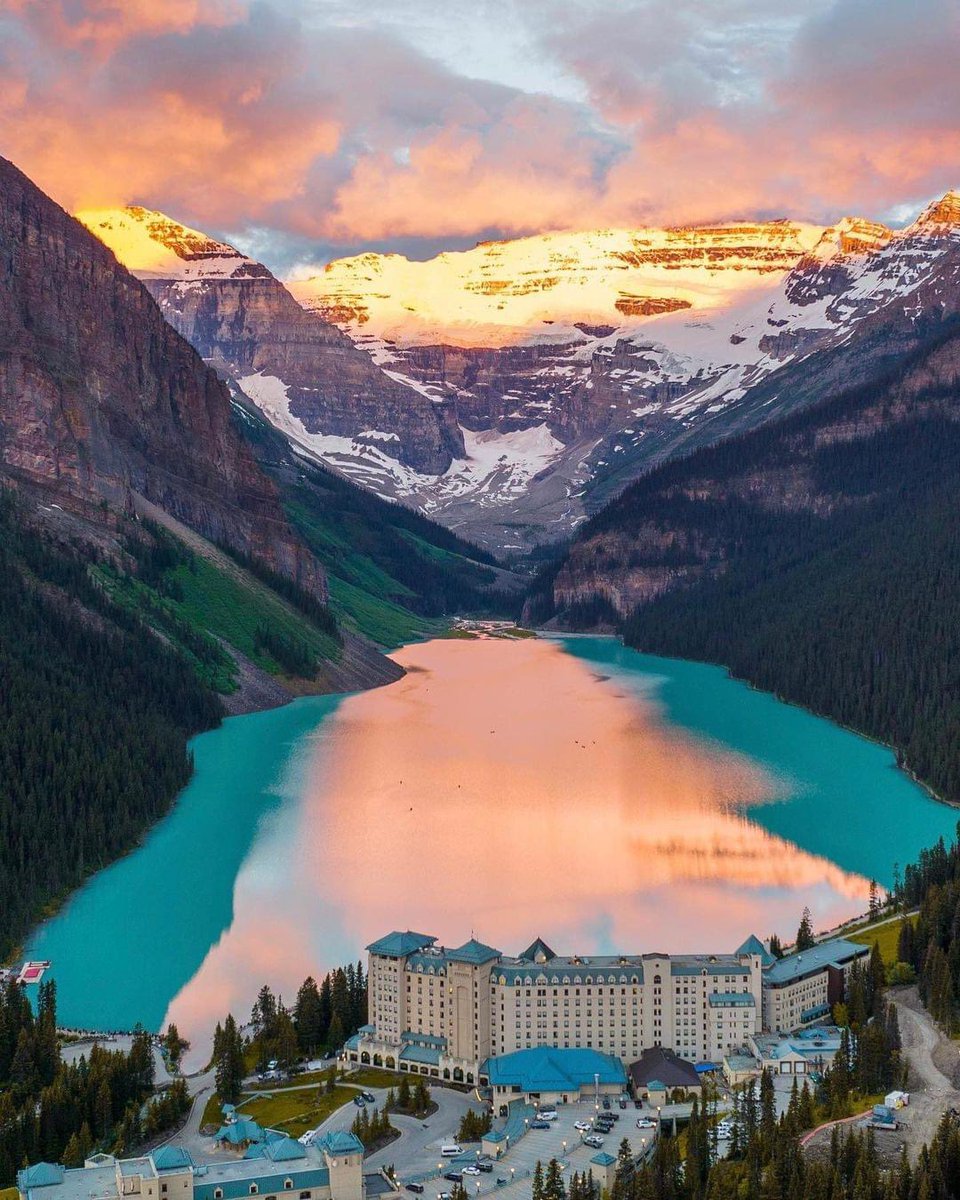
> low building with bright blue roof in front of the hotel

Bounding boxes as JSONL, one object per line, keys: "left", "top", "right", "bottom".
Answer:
{"left": 481, "top": 1046, "right": 626, "bottom": 1109}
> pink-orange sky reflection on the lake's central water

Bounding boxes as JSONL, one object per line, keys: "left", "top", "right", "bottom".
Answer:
{"left": 168, "top": 640, "right": 869, "bottom": 1070}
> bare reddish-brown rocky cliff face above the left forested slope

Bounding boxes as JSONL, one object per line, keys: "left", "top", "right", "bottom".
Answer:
{"left": 0, "top": 160, "right": 326, "bottom": 599}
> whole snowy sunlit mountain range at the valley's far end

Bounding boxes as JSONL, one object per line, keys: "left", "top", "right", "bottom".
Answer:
{"left": 79, "top": 192, "right": 960, "bottom": 550}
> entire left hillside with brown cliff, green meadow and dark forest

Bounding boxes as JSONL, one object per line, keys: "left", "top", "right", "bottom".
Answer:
{"left": 0, "top": 160, "right": 515, "bottom": 956}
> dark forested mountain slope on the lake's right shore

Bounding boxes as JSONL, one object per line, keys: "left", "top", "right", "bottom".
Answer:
{"left": 527, "top": 318, "right": 960, "bottom": 802}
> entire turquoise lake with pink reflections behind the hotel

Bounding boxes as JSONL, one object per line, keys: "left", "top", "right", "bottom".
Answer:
{"left": 28, "top": 637, "right": 956, "bottom": 1061}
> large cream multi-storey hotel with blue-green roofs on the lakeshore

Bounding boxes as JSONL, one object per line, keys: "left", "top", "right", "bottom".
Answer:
{"left": 346, "top": 930, "right": 869, "bottom": 1084}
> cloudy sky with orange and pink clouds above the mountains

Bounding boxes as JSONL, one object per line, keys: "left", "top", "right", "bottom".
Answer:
{"left": 0, "top": 0, "right": 960, "bottom": 271}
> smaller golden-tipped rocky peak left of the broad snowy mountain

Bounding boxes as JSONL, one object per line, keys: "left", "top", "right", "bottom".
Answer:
{"left": 77, "top": 208, "right": 463, "bottom": 475}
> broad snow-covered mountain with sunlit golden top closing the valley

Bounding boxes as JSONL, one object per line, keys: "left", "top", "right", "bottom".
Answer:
{"left": 289, "top": 192, "right": 960, "bottom": 548}
